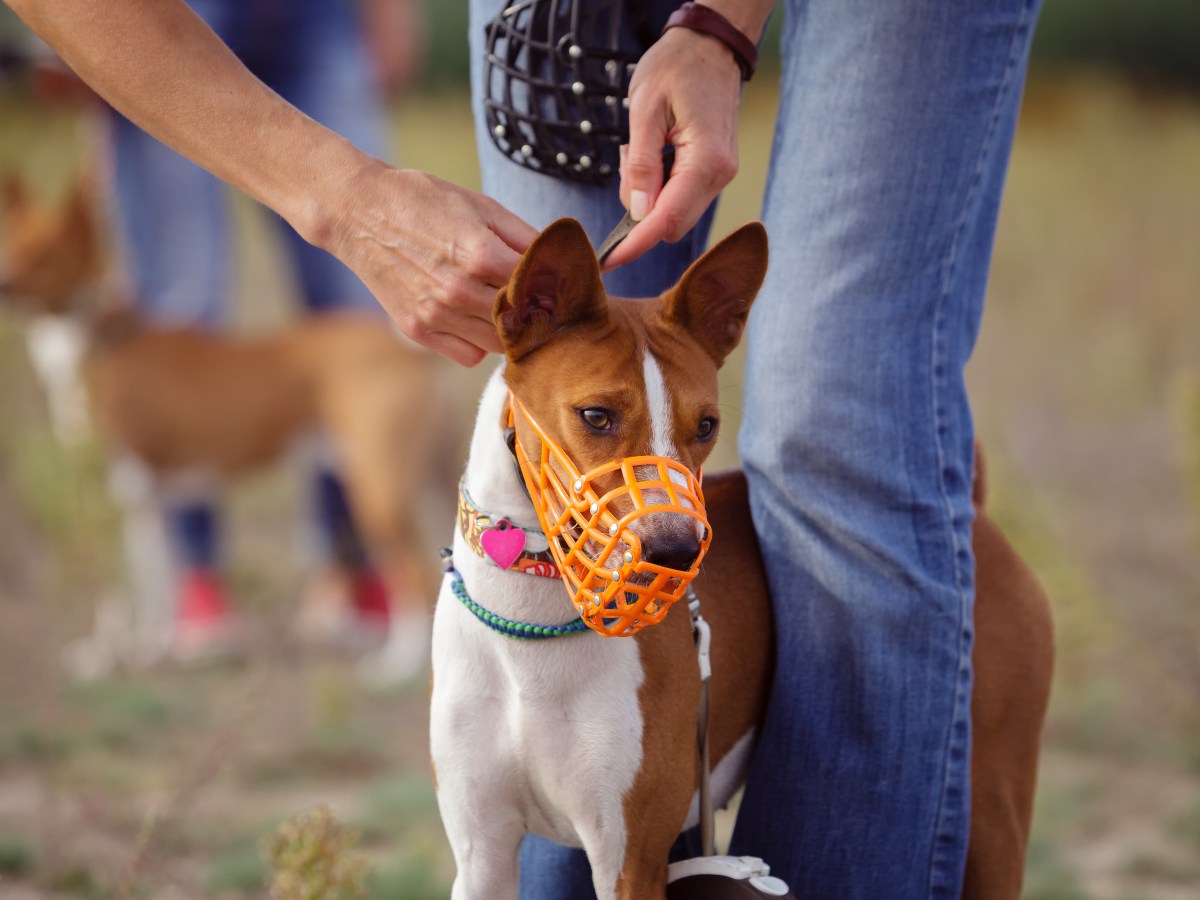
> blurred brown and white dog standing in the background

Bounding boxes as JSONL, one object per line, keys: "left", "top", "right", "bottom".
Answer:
{"left": 0, "top": 179, "right": 456, "bottom": 678}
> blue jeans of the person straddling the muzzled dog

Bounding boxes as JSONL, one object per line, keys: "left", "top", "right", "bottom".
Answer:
{"left": 472, "top": 0, "right": 1039, "bottom": 900}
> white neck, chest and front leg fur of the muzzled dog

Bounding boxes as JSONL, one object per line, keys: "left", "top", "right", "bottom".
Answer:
{"left": 430, "top": 370, "right": 644, "bottom": 900}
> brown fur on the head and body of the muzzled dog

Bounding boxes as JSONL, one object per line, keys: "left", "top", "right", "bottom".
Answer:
{"left": 496, "top": 221, "right": 1052, "bottom": 900}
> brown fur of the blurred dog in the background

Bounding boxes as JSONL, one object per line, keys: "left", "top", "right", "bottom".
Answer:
{"left": 0, "top": 174, "right": 457, "bottom": 619}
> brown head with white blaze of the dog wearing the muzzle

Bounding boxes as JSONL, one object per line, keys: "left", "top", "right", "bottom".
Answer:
{"left": 494, "top": 220, "right": 767, "bottom": 634}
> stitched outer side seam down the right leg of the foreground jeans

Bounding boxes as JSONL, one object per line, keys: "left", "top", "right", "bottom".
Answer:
{"left": 928, "top": 0, "right": 1037, "bottom": 898}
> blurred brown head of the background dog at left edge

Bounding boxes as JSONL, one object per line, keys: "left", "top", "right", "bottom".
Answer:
{"left": 0, "top": 176, "right": 102, "bottom": 316}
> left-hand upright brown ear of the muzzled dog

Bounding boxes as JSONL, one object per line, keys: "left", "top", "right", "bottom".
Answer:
{"left": 492, "top": 218, "right": 608, "bottom": 361}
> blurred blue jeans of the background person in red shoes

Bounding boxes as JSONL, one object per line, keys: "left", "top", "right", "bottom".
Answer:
{"left": 113, "top": 0, "right": 384, "bottom": 566}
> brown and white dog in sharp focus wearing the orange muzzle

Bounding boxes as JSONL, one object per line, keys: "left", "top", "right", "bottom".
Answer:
{"left": 431, "top": 220, "right": 1052, "bottom": 900}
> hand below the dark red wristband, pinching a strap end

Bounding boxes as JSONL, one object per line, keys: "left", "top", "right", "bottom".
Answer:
{"left": 605, "top": 28, "right": 742, "bottom": 270}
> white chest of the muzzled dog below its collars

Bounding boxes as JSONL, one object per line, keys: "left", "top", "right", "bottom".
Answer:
{"left": 431, "top": 549, "right": 643, "bottom": 858}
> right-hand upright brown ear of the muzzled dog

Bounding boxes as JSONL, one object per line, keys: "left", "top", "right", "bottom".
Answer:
{"left": 662, "top": 222, "right": 767, "bottom": 366}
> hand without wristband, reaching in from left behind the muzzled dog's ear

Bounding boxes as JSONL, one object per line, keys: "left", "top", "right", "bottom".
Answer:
{"left": 319, "top": 160, "right": 536, "bottom": 366}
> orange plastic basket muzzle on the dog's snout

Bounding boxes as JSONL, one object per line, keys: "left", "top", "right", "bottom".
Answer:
{"left": 509, "top": 394, "right": 713, "bottom": 637}
